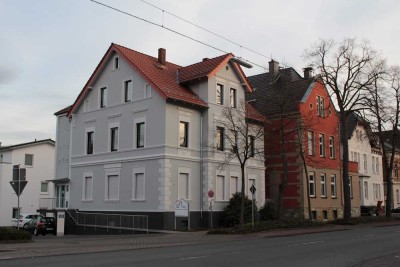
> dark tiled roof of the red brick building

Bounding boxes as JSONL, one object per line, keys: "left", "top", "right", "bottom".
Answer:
{"left": 246, "top": 68, "right": 314, "bottom": 116}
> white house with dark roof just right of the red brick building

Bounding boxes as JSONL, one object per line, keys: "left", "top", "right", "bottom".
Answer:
{"left": 347, "top": 113, "right": 384, "bottom": 207}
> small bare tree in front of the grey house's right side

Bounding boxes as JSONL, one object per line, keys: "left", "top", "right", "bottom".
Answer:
{"left": 215, "top": 102, "right": 265, "bottom": 227}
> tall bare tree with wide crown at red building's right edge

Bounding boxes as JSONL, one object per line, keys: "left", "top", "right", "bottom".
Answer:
{"left": 305, "top": 39, "right": 383, "bottom": 221}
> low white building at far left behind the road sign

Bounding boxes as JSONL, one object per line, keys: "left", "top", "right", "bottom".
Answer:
{"left": 0, "top": 139, "right": 55, "bottom": 226}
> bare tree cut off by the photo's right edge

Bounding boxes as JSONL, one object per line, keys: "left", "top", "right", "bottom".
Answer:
{"left": 365, "top": 66, "right": 400, "bottom": 217}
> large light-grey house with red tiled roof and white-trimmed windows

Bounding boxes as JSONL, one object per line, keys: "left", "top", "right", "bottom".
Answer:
{"left": 56, "top": 44, "right": 265, "bottom": 229}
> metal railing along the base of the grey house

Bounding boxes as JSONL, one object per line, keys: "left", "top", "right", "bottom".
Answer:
{"left": 68, "top": 211, "right": 149, "bottom": 234}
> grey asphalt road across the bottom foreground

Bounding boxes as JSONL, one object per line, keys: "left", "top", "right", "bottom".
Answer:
{"left": 0, "top": 226, "right": 400, "bottom": 267}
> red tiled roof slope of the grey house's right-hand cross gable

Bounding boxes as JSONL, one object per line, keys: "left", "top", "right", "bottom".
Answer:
{"left": 179, "top": 53, "right": 233, "bottom": 83}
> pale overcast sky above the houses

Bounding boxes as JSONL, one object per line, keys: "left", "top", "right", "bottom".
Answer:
{"left": 0, "top": 0, "right": 400, "bottom": 145}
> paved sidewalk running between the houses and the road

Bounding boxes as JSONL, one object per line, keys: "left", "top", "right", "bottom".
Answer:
{"left": 0, "top": 221, "right": 400, "bottom": 260}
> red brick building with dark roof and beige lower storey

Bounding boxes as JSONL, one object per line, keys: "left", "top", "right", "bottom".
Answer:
{"left": 247, "top": 61, "right": 360, "bottom": 220}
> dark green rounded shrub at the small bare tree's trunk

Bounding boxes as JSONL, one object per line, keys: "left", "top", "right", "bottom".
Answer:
{"left": 224, "top": 192, "right": 257, "bottom": 227}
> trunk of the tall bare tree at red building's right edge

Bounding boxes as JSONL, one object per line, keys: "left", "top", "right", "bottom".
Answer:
{"left": 340, "top": 116, "right": 353, "bottom": 222}
